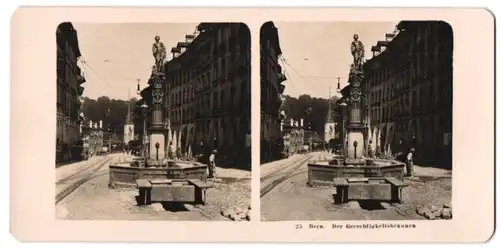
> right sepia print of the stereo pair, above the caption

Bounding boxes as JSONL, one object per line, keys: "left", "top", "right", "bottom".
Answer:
{"left": 260, "top": 20, "right": 454, "bottom": 221}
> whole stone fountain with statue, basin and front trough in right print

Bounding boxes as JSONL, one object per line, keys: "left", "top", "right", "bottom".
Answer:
{"left": 308, "top": 35, "right": 406, "bottom": 203}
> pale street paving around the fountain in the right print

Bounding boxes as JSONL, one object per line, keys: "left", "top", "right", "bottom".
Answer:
{"left": 261, "top": 153, "right": 451, "bottom": 221}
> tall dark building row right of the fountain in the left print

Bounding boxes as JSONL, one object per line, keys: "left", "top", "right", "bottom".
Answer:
{"left": 164, "top": 23, "right": 251, "bottom": 168}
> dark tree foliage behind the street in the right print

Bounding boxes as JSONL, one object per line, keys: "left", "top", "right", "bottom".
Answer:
{"left": 282, "top": 95, "right": 339, "bottom": 135}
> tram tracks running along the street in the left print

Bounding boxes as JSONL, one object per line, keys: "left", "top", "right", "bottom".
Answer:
{"left": 55, "top": 157, "right": 115, "bottom": 204}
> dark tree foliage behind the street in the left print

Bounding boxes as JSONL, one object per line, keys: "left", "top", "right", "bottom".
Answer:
{"left": 82, "top": 96, "right": 137, "bottom": 135}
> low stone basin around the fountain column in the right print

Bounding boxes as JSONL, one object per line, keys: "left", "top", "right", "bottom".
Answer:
{"left": 307, "top": 156, "right": 405, "bottom": 187}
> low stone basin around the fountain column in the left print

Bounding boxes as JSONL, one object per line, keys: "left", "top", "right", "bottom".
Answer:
{"left": 108, "top": 160, "right": 207, "bottom": 188}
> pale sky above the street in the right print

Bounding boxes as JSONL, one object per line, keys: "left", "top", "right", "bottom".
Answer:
{"left": 274, "top": 21, "right": 398, "bottom": 98}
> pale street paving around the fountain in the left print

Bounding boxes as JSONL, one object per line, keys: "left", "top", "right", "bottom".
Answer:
{"left": 56, "top": 154, "right": 251, "bottom": 221}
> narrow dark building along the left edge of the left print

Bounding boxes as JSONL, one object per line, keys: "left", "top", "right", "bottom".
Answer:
{"left": 56, "top": 22, "right": 85, "bottom": 161}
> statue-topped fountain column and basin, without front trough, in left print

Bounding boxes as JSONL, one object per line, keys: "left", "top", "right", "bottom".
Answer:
{"left": 109, "top": 36, "right": 207, "bottom": 188}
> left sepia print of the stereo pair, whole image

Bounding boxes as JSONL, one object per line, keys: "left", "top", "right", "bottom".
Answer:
{"left": 55, "top": 22, "right": 251, "bottom": 221}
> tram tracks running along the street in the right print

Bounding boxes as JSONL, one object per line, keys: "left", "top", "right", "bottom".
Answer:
{"left": 260, "top": 154, "right": 314, "bottom": 198}
